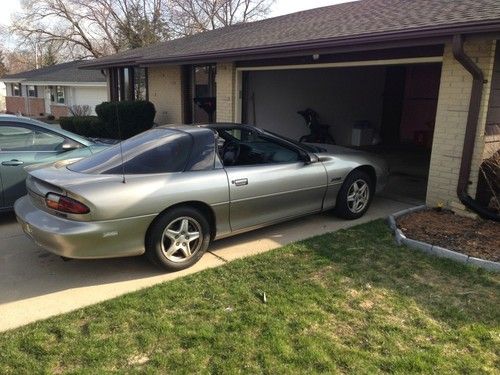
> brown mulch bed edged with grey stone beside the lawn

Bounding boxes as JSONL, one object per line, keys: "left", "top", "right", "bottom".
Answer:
{"left": 396, "top": 210, "right": 500, "bottom": 262}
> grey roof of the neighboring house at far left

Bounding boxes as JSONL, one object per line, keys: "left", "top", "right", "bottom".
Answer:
{"left": 0, "top": 60, "right": 106, "bottom": 83}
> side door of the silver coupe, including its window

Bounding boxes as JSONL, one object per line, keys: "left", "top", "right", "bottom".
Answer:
{"left": 219, "top": 129, "right": 327, "bottom": 231}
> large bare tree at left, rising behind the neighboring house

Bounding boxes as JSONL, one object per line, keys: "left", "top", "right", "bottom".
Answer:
{"left": 10, "top": 0, "right": 172, "bottom": 58}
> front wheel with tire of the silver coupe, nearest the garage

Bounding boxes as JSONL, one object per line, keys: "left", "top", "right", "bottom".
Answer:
{"left": 336, "top": 171, "right": 374, "bottom": 220}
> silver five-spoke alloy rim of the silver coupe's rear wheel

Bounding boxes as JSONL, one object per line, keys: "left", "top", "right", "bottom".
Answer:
{"left": 161, "top": 216, "right": 203, "bottom": 263}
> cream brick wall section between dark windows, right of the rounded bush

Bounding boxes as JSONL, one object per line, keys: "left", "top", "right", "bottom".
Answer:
{"left": 148, "top": 65, "right": 183, "bottom": 125}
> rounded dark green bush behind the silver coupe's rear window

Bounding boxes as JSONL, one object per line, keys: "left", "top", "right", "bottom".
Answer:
{"left": 95, "top": 100, "right": 156, "bottom": 139}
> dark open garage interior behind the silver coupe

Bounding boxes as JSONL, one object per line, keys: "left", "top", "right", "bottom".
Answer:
{"left": 241, "top": 63, "right": 441, "bottom": 204}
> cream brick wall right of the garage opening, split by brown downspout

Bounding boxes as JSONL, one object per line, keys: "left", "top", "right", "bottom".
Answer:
{"left": 427, "top": 39, "right": 495, "bottom": 213}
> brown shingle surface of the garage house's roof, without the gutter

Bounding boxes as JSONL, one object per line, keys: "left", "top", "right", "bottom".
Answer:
{"left": 84, "top": 0, "right": 500, "bottom": 66}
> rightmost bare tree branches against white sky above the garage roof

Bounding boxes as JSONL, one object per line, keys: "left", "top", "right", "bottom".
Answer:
{"left": 170, "top": 0, "right": 275, "bottom": 36}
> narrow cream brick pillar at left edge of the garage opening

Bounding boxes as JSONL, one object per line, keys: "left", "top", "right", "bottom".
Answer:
{"left": 217, "top": 63, "right": 236, "bottom": 122}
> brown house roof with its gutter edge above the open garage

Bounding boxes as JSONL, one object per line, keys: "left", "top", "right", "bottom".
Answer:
{"left": 82, "top": 0, "right": 500, "bottom": 68}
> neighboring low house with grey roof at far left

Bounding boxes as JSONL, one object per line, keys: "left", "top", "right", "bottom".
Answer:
{"left": 0, "top": 61, "right": 107, "bottom": 118}
